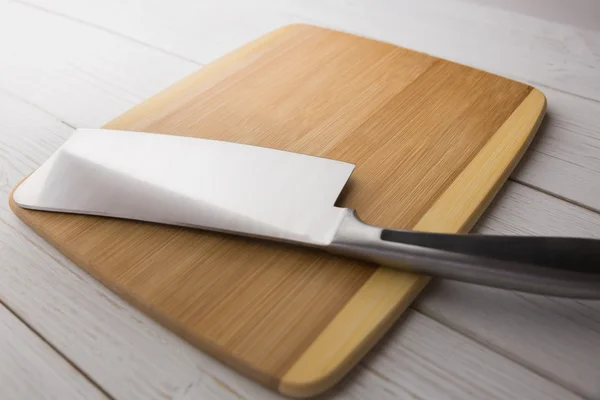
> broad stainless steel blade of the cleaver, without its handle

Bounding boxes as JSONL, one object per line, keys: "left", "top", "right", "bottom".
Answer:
{"left": 14, "top": 129, "right": 354, "bottom": 245}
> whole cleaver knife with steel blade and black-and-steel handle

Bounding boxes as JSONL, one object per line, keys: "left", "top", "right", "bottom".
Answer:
{"left": 13, "top": 129, "right": 600, "bottom": 299}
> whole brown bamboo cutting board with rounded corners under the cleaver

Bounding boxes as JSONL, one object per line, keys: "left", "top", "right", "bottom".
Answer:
{"left": 11, "top": 25, "right": 546, "bottom": 397}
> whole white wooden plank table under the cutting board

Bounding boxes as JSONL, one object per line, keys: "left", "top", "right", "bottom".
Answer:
{"left": 0, "top": 0, "right": 600, "bottom": 400}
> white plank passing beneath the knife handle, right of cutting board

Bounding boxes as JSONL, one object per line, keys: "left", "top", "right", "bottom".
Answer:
{"left": 415, "top": 184, "right": 600, "bottom": 398}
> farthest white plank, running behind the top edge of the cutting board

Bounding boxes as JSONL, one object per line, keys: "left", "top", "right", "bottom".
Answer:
{"left": 16, "top": 0, "right": 600, "bottom": 100}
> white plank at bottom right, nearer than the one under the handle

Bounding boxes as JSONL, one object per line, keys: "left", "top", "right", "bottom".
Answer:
{"left": 346, "top": 313, "right": 578, "bottom": 400}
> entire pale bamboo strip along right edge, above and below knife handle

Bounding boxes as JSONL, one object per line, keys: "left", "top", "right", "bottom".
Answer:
{"left": 279, "top": 88, "right": 547, "bottom": 397}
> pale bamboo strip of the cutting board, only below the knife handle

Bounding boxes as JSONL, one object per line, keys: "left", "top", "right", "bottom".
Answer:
{"left": 278, "top": 267, "right": 429, "bottom": 398}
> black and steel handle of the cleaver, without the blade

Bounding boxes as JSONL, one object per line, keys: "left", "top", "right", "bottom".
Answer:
{"left": 329, "top": 210, "right": 600, "bottom": 299}
